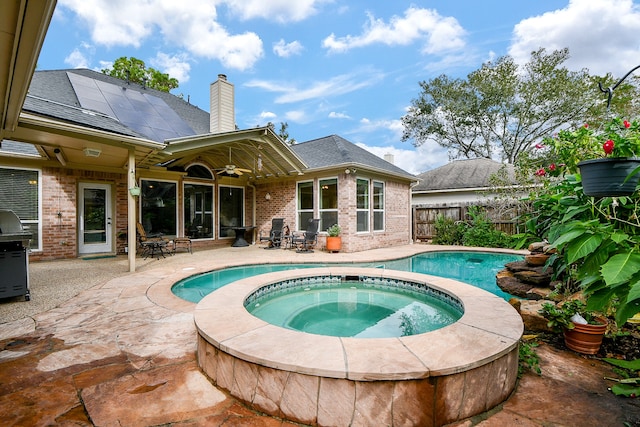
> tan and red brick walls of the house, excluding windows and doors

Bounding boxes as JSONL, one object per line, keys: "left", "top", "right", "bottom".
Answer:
{"left": 30, "top": 167, "right": 411, "bottom": 261}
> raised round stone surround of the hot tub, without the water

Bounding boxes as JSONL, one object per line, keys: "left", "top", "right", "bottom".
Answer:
{"left": 195, "top": 267, "right": 523, "bottom": 426}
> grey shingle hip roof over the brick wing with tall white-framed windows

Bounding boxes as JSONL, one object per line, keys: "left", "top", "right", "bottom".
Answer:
{"left": 291, "top": 135, "right": 415, "bottom": 179}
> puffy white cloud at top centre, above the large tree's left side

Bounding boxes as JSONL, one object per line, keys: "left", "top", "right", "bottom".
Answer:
{"left": 322, "top": 7, "right": 466, "bottom": 54}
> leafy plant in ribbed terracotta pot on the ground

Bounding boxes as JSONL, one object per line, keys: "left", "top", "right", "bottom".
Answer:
{"left": 540, "top": 299, "right": 608, "bottom": 354}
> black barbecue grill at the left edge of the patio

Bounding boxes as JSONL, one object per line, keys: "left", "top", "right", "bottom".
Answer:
{"left": 0, "top": 209, "right": 32, "bottom": 301}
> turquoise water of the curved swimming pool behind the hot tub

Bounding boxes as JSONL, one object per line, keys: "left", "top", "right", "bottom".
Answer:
{"left": 171, "top": 251, "right": 523, "bottom": 303}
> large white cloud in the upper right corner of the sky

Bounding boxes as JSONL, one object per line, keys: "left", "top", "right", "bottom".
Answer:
{"left": 509, "top": 0, "right": 640, "bottom": 77}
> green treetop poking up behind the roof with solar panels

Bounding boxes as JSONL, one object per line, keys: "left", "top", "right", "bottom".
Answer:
{"left": 101, "top": 56, "right": 178, "bottom": 92}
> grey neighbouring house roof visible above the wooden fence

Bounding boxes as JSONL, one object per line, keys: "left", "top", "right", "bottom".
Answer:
{"left": 413, "top": 158, "right": 518, "bottom": 193}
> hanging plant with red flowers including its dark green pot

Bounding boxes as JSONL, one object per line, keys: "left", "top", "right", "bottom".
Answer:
{"left": 538, "top": 118, "right": 640, "bottom": 197}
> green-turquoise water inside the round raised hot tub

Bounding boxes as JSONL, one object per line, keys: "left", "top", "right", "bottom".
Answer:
{"left": 247, "top": 280, "right": 462, "bottom": 338}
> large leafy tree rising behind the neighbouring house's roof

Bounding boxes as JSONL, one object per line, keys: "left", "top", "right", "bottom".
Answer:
{"left": 402, "top": 49, "right": 597, "bottom": 163}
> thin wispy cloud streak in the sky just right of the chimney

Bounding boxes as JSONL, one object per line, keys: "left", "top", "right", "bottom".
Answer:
{"left": 245, "top": 70, "right": 383, "bottom": 104}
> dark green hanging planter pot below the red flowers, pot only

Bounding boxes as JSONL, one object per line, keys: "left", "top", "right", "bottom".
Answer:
{"left": 578, "top": 157, "right": 640, "bottom": 197}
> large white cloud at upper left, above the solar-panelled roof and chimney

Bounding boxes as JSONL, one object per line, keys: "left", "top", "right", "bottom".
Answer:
{"left": 59, "top": 0, "right": 263, "bottom": 70}
